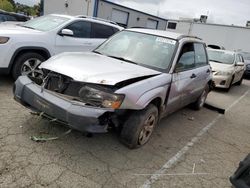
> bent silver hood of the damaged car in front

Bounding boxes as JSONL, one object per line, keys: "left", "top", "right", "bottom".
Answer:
{"left": 40, "top": 52, "right": 161, "bottom": 85}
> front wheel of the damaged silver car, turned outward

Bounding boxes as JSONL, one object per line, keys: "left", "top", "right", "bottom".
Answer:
{"left": 120, "top": 104, "right": 159, "bottom": 149}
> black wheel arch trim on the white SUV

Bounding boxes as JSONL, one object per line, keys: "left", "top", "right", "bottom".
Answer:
{"left": 8, "top": 46, "right": 51, "bottom": 74}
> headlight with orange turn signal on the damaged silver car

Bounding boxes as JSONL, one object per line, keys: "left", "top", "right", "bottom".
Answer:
{"left": 79, "top": 86, "right": 124, "bottom": 109}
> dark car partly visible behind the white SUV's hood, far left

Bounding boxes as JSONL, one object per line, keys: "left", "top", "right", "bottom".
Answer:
{"left": 0, "top": 9, "right": 30, "bottom": 23}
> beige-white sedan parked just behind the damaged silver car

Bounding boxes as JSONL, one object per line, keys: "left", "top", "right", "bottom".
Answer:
{"left": 207, "top": 49, "right": 245, "bottom": 91}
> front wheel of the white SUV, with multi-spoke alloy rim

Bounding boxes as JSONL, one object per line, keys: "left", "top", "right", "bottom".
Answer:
{"left": 12, "top": 52, "right": 46, "bottom": 80}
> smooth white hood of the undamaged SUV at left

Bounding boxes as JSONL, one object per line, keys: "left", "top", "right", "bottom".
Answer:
{"left": 0, "top": 24, "right": 41, "bottom": 36}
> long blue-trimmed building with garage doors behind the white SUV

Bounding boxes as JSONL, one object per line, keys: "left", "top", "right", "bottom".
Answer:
{"left": 42, "top": 0, "right": 167, "bottom": 30}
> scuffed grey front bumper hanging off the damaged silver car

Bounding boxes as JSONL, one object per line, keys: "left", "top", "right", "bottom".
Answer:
{"left": 14, "top": 76, "right": 114, "bottom": 133}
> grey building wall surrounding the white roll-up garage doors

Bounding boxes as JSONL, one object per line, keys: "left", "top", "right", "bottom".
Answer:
{"left": 97, "top": 0, "right": 167, "bottom": 30}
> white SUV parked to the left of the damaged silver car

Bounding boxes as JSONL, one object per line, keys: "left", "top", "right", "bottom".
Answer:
{"left": 0, "top": 14, "right": 123, "bottom": 79}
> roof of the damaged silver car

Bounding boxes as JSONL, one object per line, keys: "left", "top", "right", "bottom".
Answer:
{"left": 126, "top": 28, "right": 201, "bottom": 40}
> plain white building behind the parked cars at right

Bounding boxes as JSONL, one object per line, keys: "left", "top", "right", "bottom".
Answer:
{"left": 167, "top": 20, "right": 250, "bottom": 52}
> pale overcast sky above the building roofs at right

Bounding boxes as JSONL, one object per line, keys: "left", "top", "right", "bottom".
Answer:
{"left": 110, "top": 0, "right": 250, "bottom": 26}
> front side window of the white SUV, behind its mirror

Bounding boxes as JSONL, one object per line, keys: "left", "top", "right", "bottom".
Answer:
{"left": 65, "top": 21, "right": 91, "bottom": 38}
